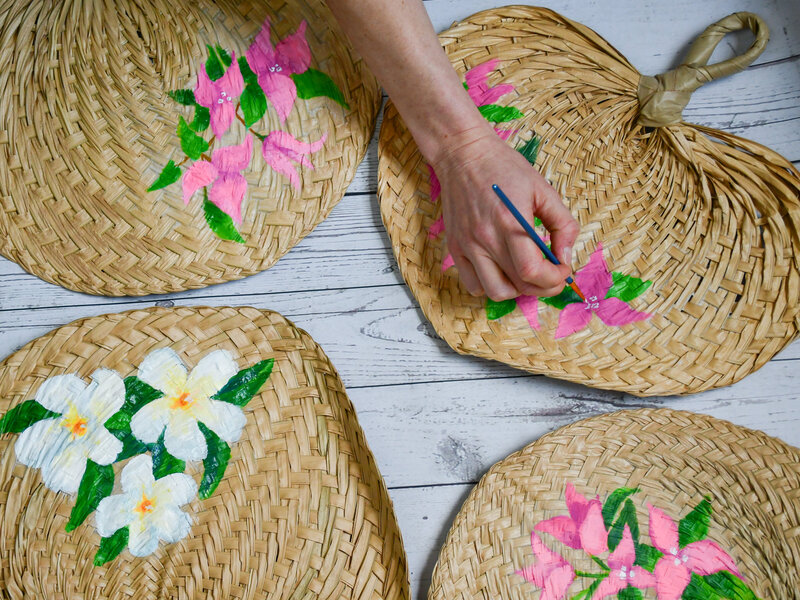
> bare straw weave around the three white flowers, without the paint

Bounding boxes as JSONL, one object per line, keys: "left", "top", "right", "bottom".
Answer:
{"left": 0, "top": 308, "right": 408, "bottom": 600}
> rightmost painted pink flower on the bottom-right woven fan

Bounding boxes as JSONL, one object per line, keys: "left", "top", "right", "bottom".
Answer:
{"left": 647, "top": 504, "right": 741, "bottom": 600}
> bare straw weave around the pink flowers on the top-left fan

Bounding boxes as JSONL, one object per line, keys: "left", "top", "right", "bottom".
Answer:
{"left": 0, "top": 0, "right": 380, "bottom": 296}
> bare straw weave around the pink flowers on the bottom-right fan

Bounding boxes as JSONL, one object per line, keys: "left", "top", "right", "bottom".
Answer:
{"left": 428, "top": 409, "right": 800, "bottom": 600}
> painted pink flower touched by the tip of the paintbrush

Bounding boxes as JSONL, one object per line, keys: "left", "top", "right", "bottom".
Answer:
{"left": 555, "top": 244, "right": 652, "bottom": 339}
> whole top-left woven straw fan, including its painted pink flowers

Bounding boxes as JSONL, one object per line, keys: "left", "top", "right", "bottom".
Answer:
{"left": 0, "top": 0, "right": 380, "bottom": 296}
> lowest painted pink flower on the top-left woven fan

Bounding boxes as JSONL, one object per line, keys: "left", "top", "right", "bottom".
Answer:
{"left": 182, "top": 137, "right": 253, "bottom": 223}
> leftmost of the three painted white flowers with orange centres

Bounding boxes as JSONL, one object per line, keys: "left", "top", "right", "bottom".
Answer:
{"left": 14, "top": 369, "right": 125, "bottom": 494}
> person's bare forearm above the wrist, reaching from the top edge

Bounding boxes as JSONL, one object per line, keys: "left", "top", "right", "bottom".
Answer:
{"left": 328, "top": 0, "right": 491, "bottom": 163}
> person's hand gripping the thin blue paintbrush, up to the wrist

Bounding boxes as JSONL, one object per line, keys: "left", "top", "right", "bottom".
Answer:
{"left": 432, "top": 128, "right": 579, "bottom": 301}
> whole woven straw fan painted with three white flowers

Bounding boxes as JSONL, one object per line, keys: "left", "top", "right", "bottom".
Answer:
{"left": 0, "top": 308, "right": 408, "bottom": 600}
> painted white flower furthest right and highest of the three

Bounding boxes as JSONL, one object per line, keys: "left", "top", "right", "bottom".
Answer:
{"left": 131, "top": 348, "right": 246, "bottom": 460}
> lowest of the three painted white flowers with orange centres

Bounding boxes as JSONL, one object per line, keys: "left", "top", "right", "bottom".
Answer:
{"left": 95, "top": 454, "right": 197, "bottom": 556}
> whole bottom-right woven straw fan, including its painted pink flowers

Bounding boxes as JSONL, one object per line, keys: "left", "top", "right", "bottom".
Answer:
{"left": 428, "top": 409, "right": 800, "bottom": 600}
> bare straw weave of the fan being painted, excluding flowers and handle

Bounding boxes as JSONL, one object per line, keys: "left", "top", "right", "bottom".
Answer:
{"left": 378, "top": 7, "right": 800, "bottom": 395}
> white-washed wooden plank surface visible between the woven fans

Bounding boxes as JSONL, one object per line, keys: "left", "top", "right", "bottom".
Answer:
{"left": 0, "top": 0, "right": 800, "bottom": 600}
